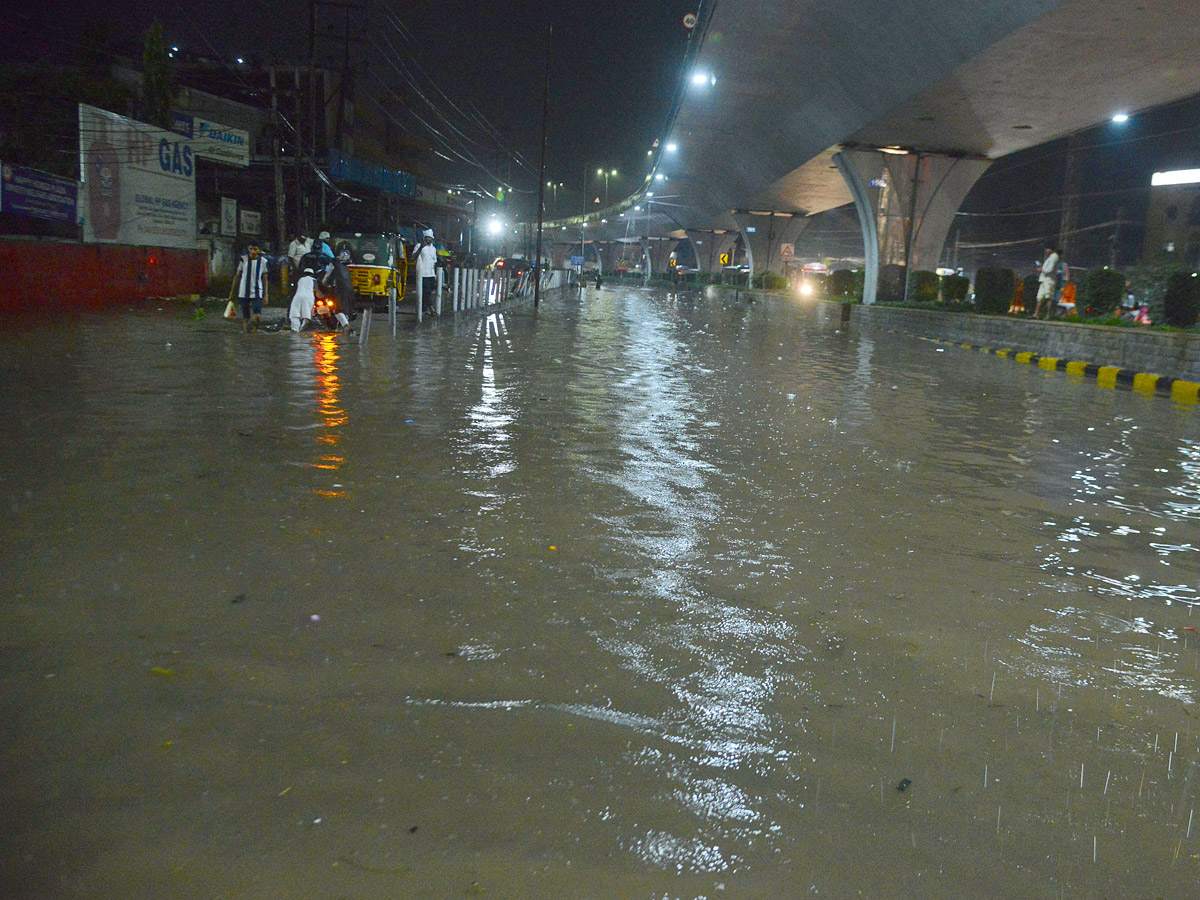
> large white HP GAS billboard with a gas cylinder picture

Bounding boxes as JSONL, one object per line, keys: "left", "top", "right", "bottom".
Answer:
{"left": 79, "top": 103, "right": 196, "bottom": 250}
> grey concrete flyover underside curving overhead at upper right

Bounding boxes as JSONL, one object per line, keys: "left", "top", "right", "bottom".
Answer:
{"left": 537, "top": 0, "right": 1200, "bottom": 289}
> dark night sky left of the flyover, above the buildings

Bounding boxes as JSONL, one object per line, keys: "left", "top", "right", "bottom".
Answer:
{"left": 9, "top": 0, "right": 696, "bottom": 214}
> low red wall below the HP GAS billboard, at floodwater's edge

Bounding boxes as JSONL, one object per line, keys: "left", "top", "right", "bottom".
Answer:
{"left": 0, "top": 240, "right": 209, "bottom": 310}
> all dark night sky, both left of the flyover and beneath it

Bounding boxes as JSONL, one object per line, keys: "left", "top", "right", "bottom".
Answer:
{"left": 7, "top": 0, "right": 1200, "bottom": 268}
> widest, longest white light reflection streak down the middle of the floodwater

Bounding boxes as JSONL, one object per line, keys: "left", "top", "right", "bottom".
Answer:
{"left": 590, "top": 298, "right": 803, "bottom": 871}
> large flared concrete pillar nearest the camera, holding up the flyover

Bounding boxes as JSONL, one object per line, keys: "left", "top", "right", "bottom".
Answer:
{"left": 834, "top": 150, "right": 991, "bottom": 304}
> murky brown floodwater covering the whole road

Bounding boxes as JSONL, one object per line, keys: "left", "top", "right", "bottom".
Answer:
{"left": 0, "top": 289, "right": 1200, "bottom": 900}
